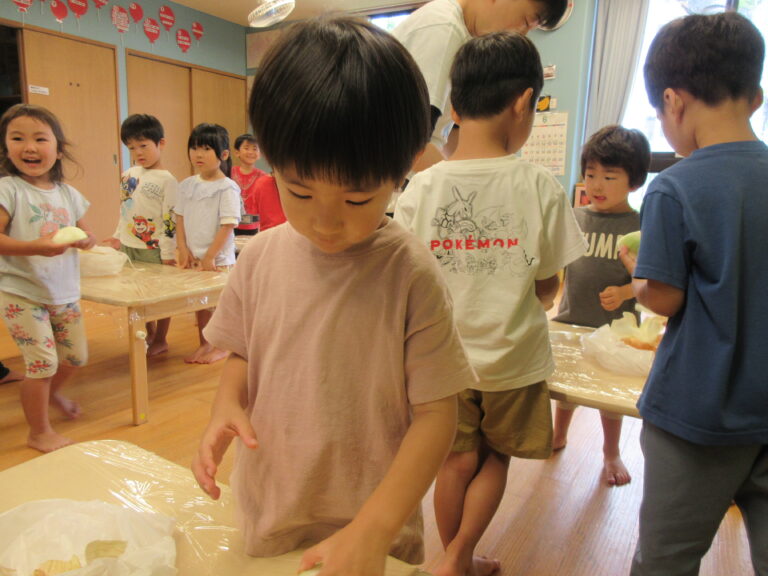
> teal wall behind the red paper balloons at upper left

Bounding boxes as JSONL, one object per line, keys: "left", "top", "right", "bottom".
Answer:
{"left": 0, "top": 0, "right": 246, "bottom": 140}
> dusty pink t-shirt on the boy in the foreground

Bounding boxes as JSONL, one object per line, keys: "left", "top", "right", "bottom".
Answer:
{"left": 205, "top": 220, "right": 475, "bottom": 563}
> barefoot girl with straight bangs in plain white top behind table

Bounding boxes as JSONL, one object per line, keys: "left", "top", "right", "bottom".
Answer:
{"left": 175, "top": 124, "right": 241, "bottom": 364}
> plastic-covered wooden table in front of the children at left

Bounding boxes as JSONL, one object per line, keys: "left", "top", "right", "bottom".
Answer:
{"left": 80, "top": 263, "right": 227, "bottom": 425}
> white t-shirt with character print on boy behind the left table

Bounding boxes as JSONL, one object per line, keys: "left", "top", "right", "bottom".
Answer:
{"left": 114, "top": 166, "right": 179, "bottom": 260}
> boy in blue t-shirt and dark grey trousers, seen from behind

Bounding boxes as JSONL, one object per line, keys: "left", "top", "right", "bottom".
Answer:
{"left": 621, "top": 12, "right": 768, "bottom": 576}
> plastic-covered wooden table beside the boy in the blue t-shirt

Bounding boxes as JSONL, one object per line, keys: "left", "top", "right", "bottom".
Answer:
{"left": 547, "top": 322, "right": 645, "bottom": 418}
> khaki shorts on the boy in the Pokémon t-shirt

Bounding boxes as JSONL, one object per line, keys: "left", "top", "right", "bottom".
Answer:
{"left": 452, "top": 382, "right": 552, "bottom": 459}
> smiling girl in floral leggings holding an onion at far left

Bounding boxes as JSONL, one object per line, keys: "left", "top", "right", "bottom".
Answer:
{"left": 0, "top": 104, "right": 96, "bottom": 452}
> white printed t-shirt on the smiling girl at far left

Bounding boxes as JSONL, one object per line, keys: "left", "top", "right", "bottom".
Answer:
{"left": 0, "top": 176, "right": 90, "bottom": 304}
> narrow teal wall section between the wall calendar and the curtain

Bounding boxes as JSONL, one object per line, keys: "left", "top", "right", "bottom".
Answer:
{"left": 530, "top": 0, "right": 597, "bottom": 196}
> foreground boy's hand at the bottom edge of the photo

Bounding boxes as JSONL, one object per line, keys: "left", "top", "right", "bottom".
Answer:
{"left": 299, "top": 521, "right": 390, "bottom": 576}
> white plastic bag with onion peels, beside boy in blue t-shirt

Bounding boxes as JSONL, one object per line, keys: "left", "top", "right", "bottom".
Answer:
{"left": 581, "top": 324, "right": 654, "bottom": 376}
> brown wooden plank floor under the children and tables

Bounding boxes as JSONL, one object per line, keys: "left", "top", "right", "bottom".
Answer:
{"left": 0, "top": 303, "right": 754, "bottom": 576}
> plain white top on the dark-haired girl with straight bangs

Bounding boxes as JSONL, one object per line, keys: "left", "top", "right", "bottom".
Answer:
{"left": 175, "top": 175, "right": 242, "bottom": 266}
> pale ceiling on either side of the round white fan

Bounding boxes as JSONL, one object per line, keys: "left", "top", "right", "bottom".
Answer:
{"left": 174, "top": 0, "right": 424, "bottom": 26}
